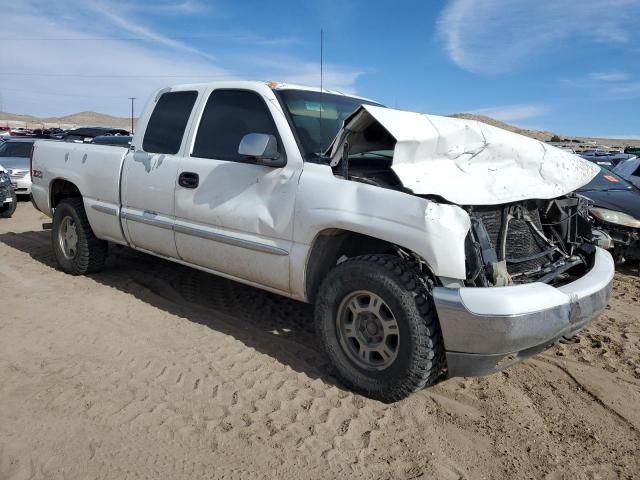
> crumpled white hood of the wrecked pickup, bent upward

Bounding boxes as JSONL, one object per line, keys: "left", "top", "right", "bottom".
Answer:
{"left": 329, "top": 105, "right": 599, "bottom": 205}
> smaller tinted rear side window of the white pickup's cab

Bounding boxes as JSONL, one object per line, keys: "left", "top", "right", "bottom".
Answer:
{"left": 142, "top": 91, "right": 198, "bottom": 154}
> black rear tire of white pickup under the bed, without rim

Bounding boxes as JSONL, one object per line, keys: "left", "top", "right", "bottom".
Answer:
{"left": 51, "top": 197, "right": 108, "bottom": 275}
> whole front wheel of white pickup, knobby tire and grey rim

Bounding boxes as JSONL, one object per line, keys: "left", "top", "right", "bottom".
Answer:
{"left": 315, "top": 255, "right": 444, "bottom": 402}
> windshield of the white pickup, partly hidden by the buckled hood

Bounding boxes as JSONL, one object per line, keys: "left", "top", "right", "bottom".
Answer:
{"left": 274, "top": 90, "right": 379, "bottom": 160}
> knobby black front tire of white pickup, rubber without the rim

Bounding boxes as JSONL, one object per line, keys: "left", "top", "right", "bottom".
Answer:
{"left": 315, "top": 255, "right": 445, "bottom": 402}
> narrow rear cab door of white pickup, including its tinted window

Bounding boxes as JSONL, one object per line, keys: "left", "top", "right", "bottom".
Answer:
{"left": 121, "top": 91, "right": 198, "bottom": 258}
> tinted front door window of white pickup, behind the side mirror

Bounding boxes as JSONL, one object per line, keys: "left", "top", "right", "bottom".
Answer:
{"left": 192, "top": 90, "right": 284, "bottom": 161}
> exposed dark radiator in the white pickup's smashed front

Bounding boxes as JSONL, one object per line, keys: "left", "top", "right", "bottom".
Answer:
{"left": 475, "top": 205, "right": 549, "bottom": 275}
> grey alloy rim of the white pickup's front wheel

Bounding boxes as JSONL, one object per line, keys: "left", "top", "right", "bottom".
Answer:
{"left": 336, "top": 291, "right": 400, "bottom": 370}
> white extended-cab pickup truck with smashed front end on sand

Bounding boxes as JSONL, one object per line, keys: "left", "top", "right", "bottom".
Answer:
{"left": 31, "top": 81, "right": 614, "bottom": 401}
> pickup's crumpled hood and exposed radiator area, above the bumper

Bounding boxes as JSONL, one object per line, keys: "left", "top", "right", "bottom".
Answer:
{"left": 329, "top": 105, "right": 599, "bottom": 287}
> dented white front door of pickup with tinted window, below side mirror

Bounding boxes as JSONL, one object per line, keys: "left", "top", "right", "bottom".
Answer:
{"left": 175, "top": 89, "right": 302, "bottom": 292}
